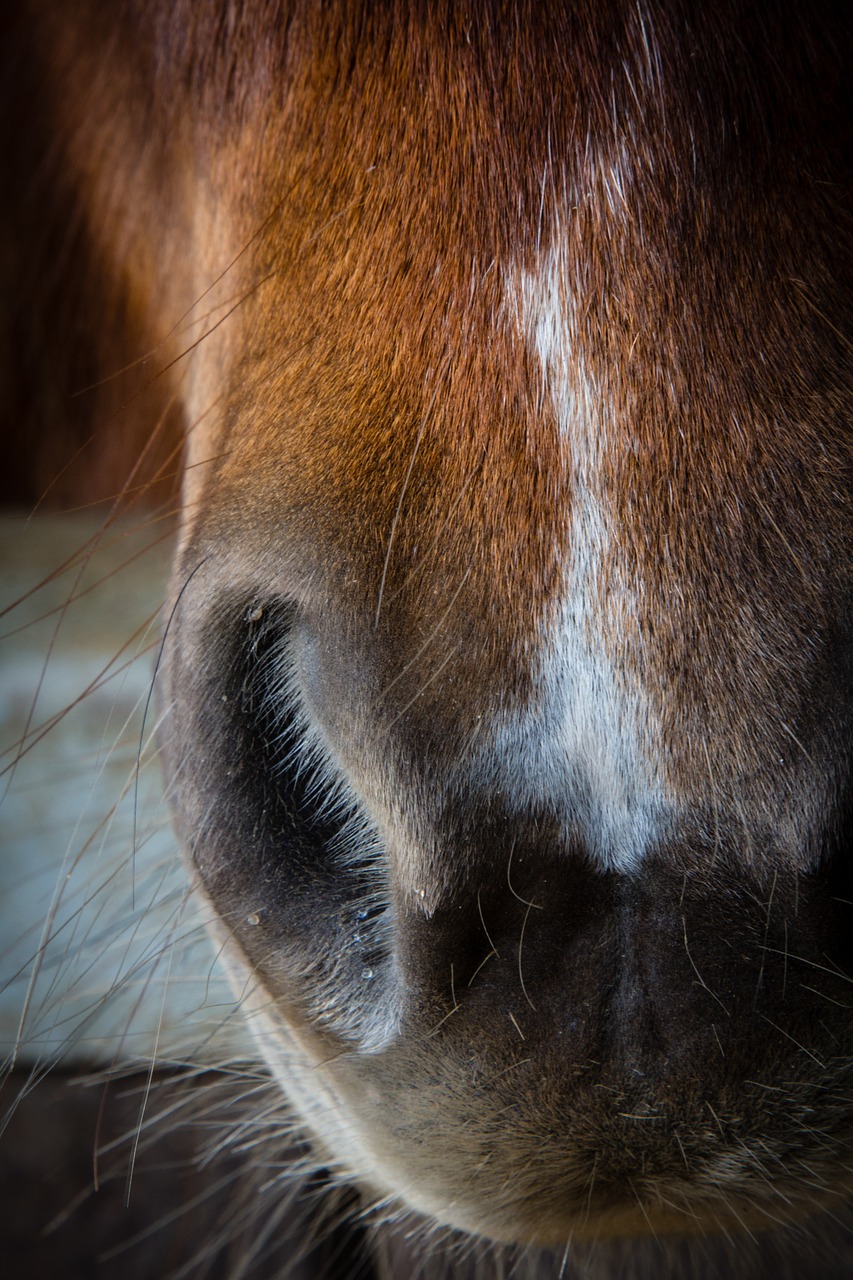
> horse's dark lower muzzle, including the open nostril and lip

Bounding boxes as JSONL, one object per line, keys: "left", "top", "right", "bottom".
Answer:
{"left": 166, "top": 581, "right": 853, "bottom": 1245}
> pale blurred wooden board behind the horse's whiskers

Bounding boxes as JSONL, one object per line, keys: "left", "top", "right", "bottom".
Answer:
{"left": 0, "top": 516, "right": 246, "bottom": 1069}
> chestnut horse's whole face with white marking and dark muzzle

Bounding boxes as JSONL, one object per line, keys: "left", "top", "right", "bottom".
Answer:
{"left": 8, "top": 3, "right": 853, "bottom": 1259}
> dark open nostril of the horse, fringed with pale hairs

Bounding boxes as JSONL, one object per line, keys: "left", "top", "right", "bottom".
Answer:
{"left": 173, "top": 595, "right": 393, "bottom": 1038}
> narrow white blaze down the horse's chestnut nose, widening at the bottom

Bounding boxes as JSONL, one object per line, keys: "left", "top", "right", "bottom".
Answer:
{"left": 491, "top": 235, "right": 666, "bottom": 870}
